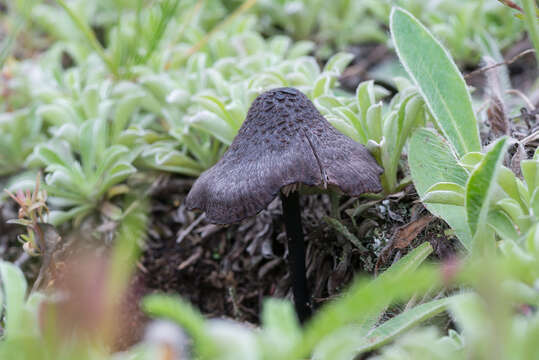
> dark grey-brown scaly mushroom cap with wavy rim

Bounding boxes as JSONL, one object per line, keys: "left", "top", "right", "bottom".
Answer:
{"left": 186, "top": 88, "right": 383, "bottom": 224}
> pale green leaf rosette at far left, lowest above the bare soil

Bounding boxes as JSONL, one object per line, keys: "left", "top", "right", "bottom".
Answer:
{"left": 28, "top": 117, "right": 137, "bottom": 225}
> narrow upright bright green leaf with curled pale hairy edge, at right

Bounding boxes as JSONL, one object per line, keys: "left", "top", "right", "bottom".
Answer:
{"left": 465, "top": 137, "right": 507, "bottom": 246}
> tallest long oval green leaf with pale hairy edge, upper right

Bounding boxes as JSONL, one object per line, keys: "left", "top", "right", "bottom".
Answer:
{"left": 390, "top": 8, "right": 481, "bottom": 157}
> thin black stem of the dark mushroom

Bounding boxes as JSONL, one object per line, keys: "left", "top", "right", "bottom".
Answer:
{"left": 281, "top": 191, "right": 311, "bottom": 324}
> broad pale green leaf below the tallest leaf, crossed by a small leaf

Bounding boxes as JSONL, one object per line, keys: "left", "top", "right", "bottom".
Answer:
{"left": 408, "top": 129, "right": 472, "bottom": 249}
